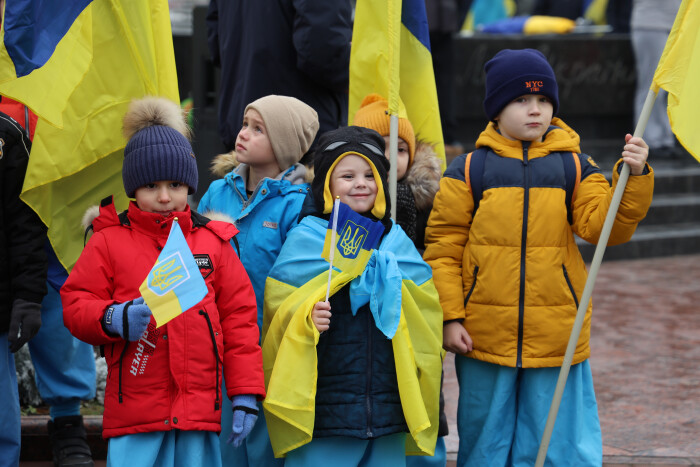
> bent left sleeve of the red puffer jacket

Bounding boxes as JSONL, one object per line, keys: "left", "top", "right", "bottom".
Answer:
{"left": 61, "top": 232, "right": 121, "bottom": 345}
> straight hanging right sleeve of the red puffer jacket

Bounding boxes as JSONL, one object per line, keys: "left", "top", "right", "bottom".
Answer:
{"left": 214, "top": 242, "right": 265, "bottom": 399}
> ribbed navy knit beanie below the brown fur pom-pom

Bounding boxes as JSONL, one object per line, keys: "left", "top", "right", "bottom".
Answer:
{"left": 122, "top": 125, "right": 199, "bottom": 198}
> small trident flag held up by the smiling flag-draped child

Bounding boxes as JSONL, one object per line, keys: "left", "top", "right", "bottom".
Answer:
{"left": 321, "top": 202, "right": 384, "bottom": 277}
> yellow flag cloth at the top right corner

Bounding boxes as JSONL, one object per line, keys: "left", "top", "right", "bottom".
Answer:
{"left": 651, "top": 0, "right": 700, "bottom": 162}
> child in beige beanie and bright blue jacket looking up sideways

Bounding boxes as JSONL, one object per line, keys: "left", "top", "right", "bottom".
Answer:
{"left": 198, "top": 95, "right": 318, "bottom": 467}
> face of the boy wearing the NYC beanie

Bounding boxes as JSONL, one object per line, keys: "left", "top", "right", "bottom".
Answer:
{"left": 495, "top": 94, "right": 554, "bottom": 141}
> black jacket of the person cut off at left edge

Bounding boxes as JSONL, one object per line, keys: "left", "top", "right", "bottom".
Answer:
{"left": 0, "top": 112, "right": 47, "bottom": 333}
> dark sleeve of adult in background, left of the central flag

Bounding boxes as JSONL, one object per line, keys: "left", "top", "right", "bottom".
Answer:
{"left": 292, "top": 0, "right": 352, "bottom": 92}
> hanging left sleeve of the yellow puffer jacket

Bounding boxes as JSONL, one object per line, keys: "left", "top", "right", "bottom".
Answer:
{"left": 423, "top": 157, "right": 474, "bottom": 321}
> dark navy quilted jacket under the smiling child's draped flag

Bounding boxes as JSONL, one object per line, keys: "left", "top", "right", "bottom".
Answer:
{"left": 314, "top": 285, "right": 408, "bottom": 439}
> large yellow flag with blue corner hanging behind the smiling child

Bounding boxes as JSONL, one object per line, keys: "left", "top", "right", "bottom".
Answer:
{"left": 348, "top": 0, "right": 445, "bottom": 168}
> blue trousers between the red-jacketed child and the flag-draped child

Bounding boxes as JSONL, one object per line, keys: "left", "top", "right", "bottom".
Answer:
{"left": 219, "top": 383, "right": 284, "bottom": 467}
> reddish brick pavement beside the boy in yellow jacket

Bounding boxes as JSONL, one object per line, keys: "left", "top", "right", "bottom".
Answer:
{"left": 444, "top": 255, "right": 700, "bottom": 467}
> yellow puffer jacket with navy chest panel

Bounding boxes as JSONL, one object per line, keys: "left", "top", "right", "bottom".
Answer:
{"left": 424, "top": 118, "right": 654, "bottom": 368}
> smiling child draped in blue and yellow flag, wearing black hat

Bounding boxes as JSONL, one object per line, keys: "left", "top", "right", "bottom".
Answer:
{"left": 263, "top": 127, "right": 442, "bottom": 466}
